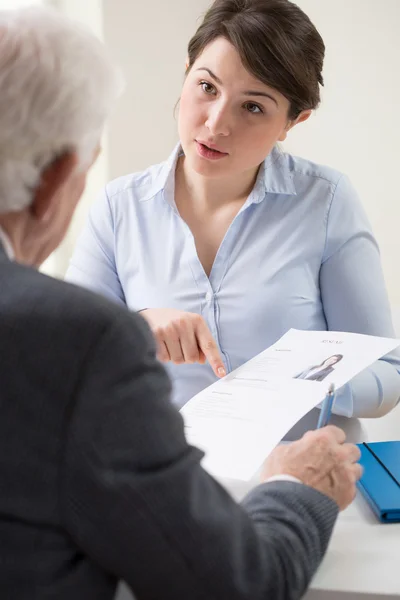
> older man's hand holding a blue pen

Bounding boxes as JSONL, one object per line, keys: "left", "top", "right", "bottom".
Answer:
{"left": 262, "top": 425, "right": 362, "bottom": 510}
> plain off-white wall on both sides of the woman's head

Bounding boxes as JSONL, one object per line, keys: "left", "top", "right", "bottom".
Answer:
{"left": 103, "top": 0, "right": 400, "bottom": 305}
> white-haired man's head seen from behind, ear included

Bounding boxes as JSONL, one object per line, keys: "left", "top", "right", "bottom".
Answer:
{"left": 0, "top": 7, "right": 122, "bottom": 265}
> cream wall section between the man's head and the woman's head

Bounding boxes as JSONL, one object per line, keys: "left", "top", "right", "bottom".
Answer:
{"left": 103, "top": 0, "right": 210, "bottom": 177}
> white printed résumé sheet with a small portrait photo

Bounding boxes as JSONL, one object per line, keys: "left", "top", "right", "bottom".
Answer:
{"left": 180, "top": 329, "right": 400, "bottom": 481}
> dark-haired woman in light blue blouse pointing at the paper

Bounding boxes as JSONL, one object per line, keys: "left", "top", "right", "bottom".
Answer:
{"left": 67, "top": 0, "right": 400, "bottom": 416}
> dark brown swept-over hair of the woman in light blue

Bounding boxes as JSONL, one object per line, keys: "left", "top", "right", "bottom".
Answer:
{"left": 186, "top": 0, "right": 325, "bottom": 120}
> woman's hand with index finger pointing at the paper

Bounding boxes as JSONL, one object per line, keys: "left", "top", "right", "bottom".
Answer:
{"left": 140, "top": 308, "right": 226, "bottom": 377}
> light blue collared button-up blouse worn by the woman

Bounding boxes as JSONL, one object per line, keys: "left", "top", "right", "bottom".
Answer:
{"left": 67, "top": 146, "right": 400, "bottom": 416}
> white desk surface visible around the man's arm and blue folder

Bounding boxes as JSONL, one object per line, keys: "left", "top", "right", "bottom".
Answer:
{"left": 117, "top": 407, "right": 400, "bottom": 600}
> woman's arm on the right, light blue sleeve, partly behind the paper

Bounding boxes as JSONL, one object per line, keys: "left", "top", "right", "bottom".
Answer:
{"left": 320, "top": 177, "right": 400, "bottom": 417}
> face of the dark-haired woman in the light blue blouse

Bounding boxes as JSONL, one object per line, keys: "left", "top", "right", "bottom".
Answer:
{"left": 178, "top": 37, "right": 309, "bottom": 177}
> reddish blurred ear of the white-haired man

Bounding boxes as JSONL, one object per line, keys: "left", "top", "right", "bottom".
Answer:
{"left": 30, "top": 152, "right": 78, "bottom": 221}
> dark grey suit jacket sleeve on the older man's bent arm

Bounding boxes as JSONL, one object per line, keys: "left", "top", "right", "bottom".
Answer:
{"left": 60, "top": 311, "right": 337, "bottom": 600}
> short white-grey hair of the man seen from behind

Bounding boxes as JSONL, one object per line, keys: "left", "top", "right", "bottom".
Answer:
{"left": 0, "top": 6, "right": 123, "bottom": 213}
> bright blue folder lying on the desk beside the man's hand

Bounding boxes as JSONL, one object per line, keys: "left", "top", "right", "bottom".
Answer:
{"left": 358, "top": 442, "right": 400, "bottom": 523}
